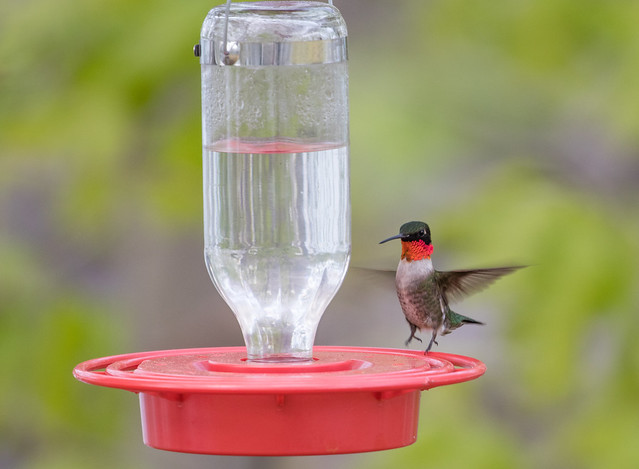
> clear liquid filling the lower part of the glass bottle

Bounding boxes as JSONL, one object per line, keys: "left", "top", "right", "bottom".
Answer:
{"left": 204, "top": 141, "right": 350, "bottom": 360}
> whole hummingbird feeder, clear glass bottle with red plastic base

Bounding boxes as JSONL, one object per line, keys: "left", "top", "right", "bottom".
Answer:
{"left": 74, "top": 1, "right": 485, "bottom": 456}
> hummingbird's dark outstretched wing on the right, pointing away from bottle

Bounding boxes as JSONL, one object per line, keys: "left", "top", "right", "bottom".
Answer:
{"left": 435, "top": 265, "right": 525, "bottom": 302}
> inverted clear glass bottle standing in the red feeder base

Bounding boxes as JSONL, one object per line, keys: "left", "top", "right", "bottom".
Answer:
{"left": 200, "top": 2, "right": 350, "bottom": 361}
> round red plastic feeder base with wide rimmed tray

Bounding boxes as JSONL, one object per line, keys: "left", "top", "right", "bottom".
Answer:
{"left": 74, "top": 347, "right": 486, "bottom": 456}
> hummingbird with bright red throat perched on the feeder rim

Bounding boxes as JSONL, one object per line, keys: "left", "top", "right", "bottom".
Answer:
{"left": 379, "top": 221, "right": 524, "bottom": 354}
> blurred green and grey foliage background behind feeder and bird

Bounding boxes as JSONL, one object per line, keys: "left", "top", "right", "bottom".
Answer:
{"left": 0, "top": 0, "right": 639, "bottom": 469}
